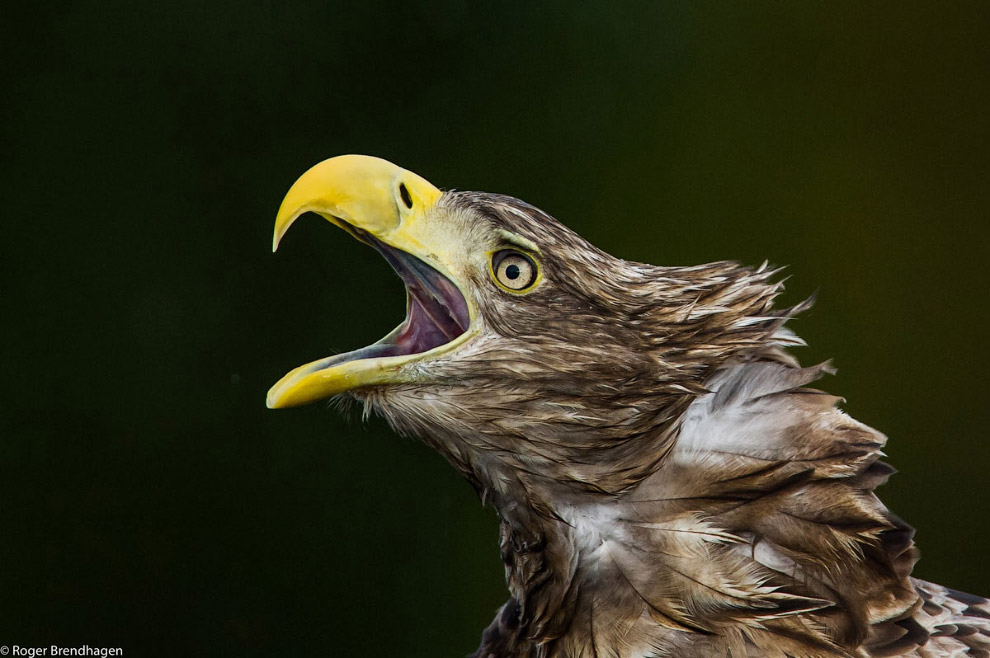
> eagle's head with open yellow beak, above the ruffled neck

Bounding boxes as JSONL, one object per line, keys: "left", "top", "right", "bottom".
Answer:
{"left": 268, "top": 155, "right": 793, "bottom": 503}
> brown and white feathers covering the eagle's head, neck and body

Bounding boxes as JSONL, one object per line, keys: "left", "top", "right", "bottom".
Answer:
{"left": 270, "top": 160, "right": 990, "bottom": 658}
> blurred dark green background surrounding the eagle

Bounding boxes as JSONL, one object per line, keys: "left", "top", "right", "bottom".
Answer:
{"left": 0, "top": 0, "right": 990, "bottom": 656}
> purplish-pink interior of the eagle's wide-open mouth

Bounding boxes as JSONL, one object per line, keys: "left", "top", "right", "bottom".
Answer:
{"left": 304, "top": 222, "right": 470, "bottom": 372}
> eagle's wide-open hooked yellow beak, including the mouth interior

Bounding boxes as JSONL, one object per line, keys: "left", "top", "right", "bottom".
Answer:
{"left": 268, "top": 155, "right": 475, "bottom": 409}
